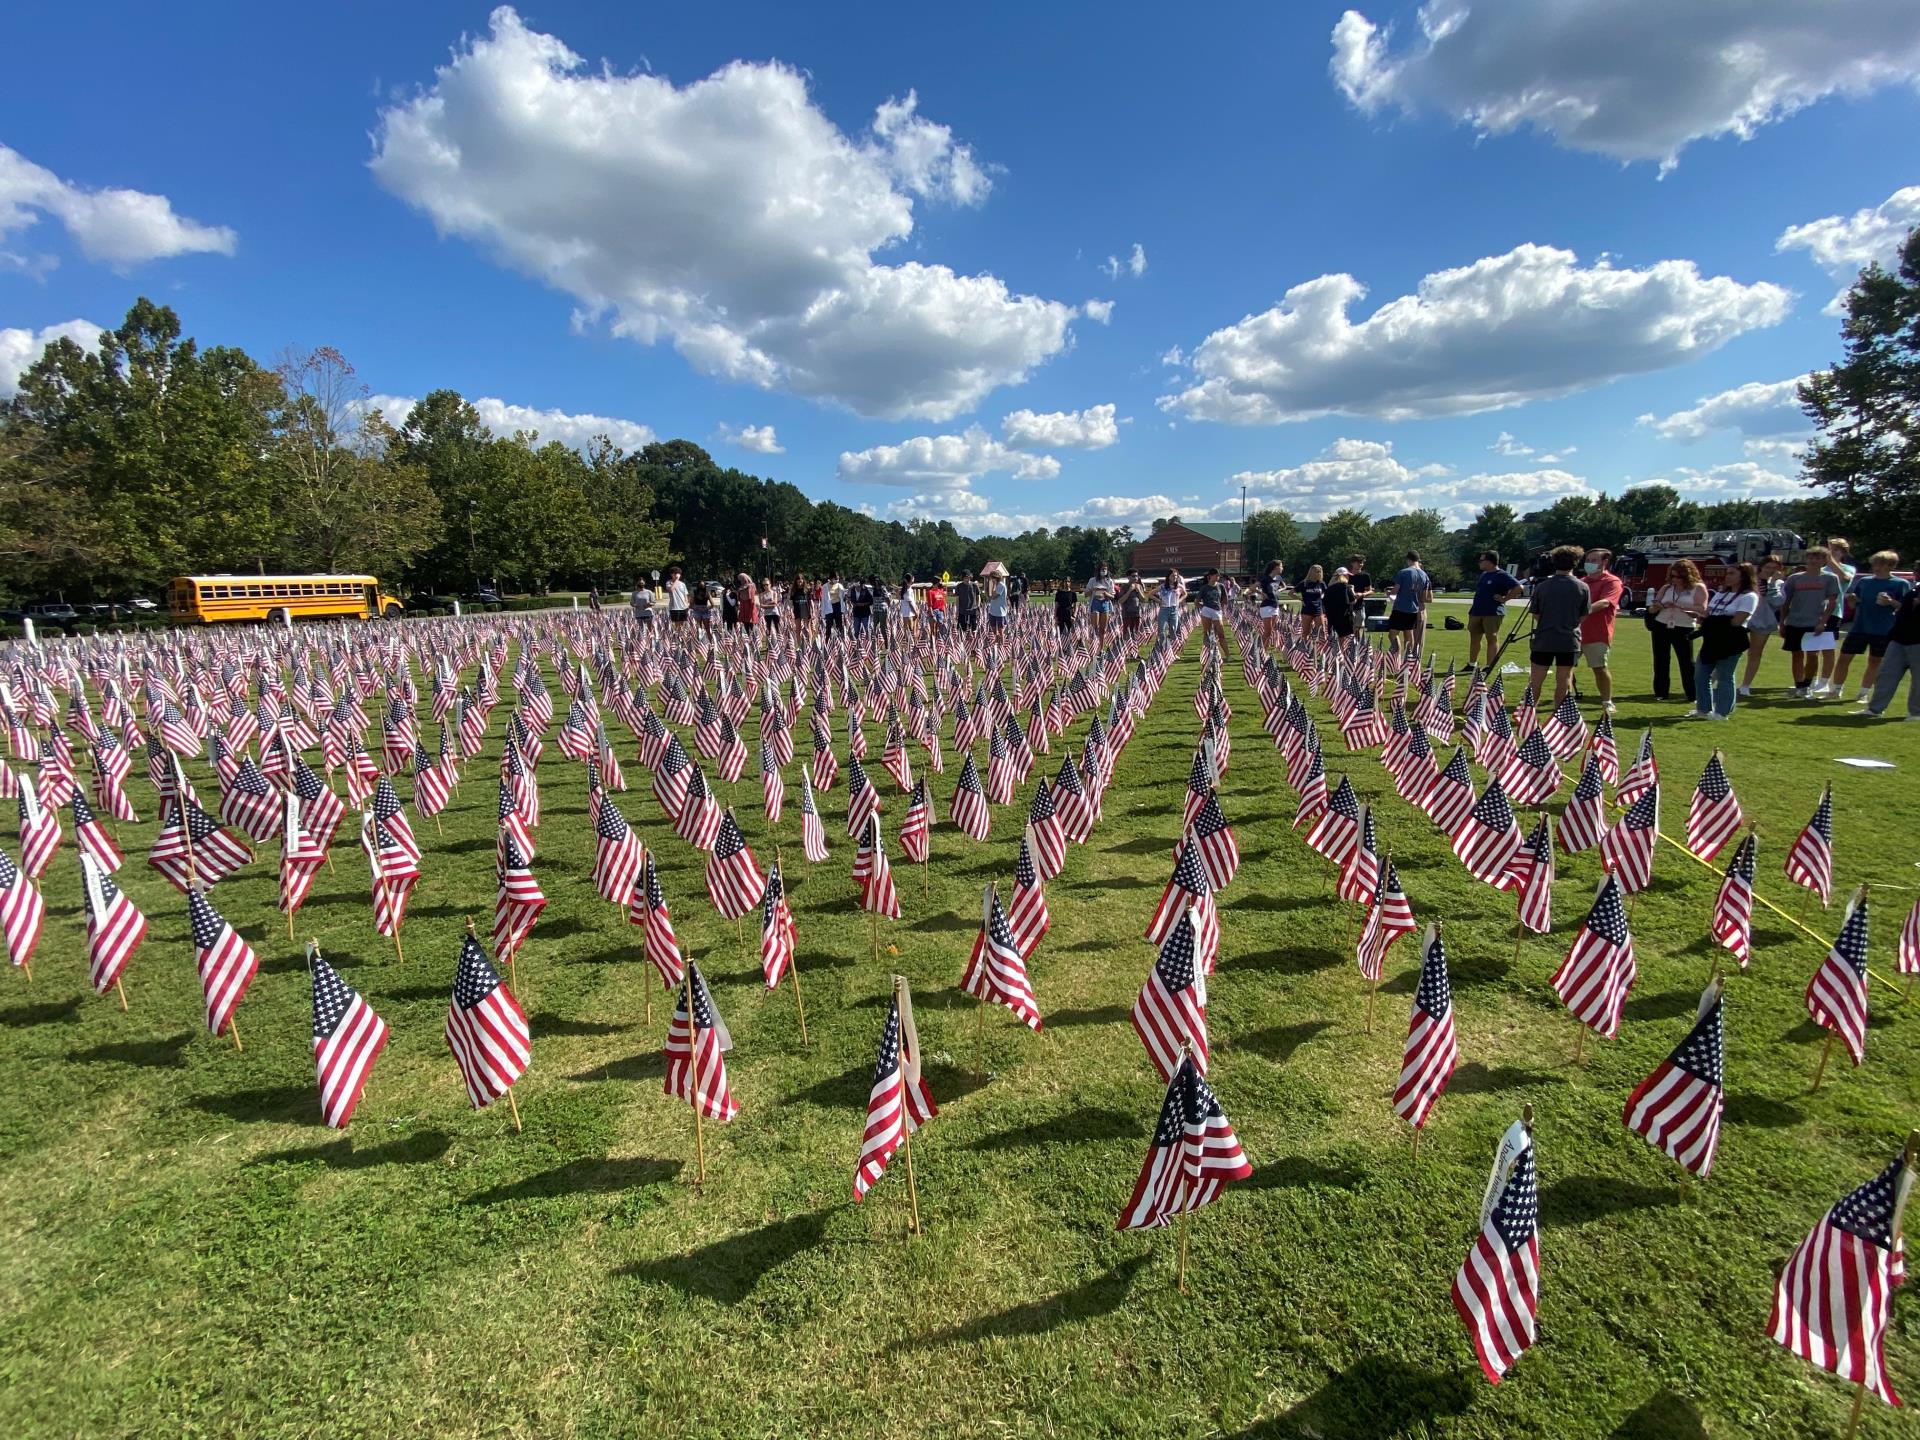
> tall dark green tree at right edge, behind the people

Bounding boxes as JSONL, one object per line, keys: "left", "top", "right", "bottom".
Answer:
{"left": 1799, "top": 228, "right": 1920, "bottom": 555}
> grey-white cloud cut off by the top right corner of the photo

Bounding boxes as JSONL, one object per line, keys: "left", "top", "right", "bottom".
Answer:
{"left": 1329, "top": 0, "right": 1920, "bottom": 171}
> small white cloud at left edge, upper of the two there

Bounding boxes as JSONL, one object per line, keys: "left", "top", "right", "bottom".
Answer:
{"left": 0, "top": 146, "right": 238, "bottom": 271}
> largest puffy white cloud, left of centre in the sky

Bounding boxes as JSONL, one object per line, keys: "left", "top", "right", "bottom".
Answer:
{"left": 371, "top": 6, "right": 1075, "bottom": 420}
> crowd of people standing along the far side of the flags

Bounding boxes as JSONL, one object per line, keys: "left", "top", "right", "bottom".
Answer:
{"left": 632, "top": 538, "right": 1920, "bottom": 720}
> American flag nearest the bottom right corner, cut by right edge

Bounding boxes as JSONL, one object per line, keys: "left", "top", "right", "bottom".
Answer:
{"left": 1768, "top": 1140, "right": 1914, "bottom": 1405}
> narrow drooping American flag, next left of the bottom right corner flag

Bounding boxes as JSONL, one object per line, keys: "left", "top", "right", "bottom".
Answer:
{"left": 1453, "top": 1121, "right": 1540, "bottom": 1384}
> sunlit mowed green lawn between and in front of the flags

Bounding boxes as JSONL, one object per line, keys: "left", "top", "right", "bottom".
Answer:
{"left": 0, "top": 626, "right": 1920, "bottom": 1436}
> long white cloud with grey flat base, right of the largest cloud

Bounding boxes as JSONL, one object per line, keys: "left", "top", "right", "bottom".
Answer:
{"left": 1160, "top": 246, "right": 1791, "bottom": 424}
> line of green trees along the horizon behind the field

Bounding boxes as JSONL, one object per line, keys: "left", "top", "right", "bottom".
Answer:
{"left": 0, "top": 230, "right": 1920, "bottom": 601}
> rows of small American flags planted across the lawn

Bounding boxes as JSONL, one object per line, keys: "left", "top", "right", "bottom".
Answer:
{"left": 0, "top": 612, "right": 1920, "bottom": 1421}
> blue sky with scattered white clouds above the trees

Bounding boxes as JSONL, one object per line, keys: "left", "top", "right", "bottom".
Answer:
{"left": 0, "top": 0, "right": 1920, "bottom": 532}
